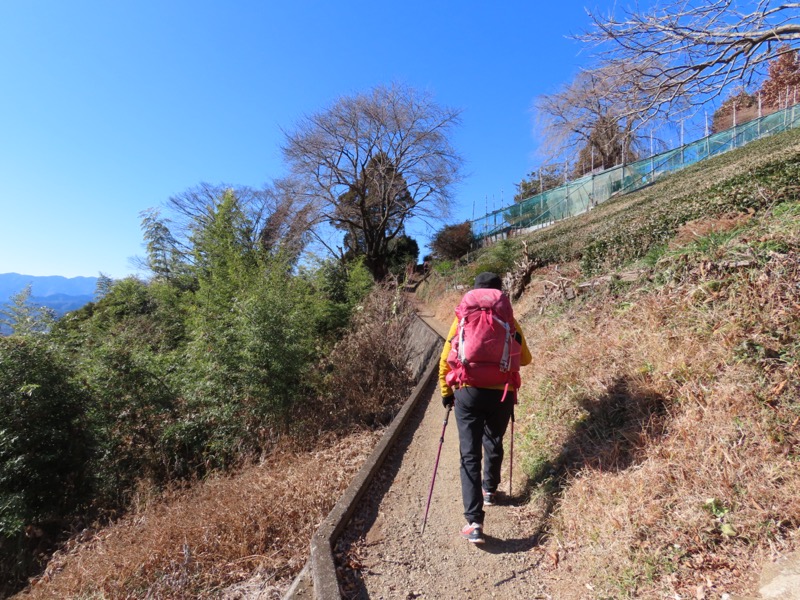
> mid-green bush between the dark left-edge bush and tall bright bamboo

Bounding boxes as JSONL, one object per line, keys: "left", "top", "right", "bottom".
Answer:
{"left": 52, "top": 278, "right": 187, "bottom": 496}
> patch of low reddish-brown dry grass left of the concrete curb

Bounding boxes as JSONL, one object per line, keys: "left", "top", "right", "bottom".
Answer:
{"left": 19, "top": 432, "right": 378, "bottom": 599}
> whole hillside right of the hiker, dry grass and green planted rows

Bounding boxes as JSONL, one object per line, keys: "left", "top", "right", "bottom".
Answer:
{"left": 410, "top": 125, "right": 800, "bottom": 598}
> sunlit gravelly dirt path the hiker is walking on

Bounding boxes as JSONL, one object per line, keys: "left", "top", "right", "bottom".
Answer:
{"left": 337, "top": 313, "right": 548, "bottom": 599}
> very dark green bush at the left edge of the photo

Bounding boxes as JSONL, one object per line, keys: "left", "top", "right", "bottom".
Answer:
{"left": 0, "top": 336, "right": 91, "bottom": 537}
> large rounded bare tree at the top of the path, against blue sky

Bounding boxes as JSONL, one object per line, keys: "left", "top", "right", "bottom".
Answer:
{"left": 283, "top": 85, "right": 462, "bottom": 279}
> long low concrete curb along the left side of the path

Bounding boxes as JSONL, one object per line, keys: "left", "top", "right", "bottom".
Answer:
{"left": 284, "top": 316, "right": 443, "bottom": 600}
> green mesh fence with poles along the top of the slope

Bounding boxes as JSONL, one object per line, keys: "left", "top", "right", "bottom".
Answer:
{"left": 471, "top": 105, "right": 800, "bottom": 242}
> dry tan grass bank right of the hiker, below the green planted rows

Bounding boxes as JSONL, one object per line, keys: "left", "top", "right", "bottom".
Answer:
{"left": 521, "top": 247, "right": 800, "bottom": 599}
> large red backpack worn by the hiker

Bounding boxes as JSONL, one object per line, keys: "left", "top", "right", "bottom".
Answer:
{"left": 446, "top": 288, "right": 522, "bottom": 400}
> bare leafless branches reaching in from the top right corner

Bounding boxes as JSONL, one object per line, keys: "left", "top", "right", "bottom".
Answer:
{"left": 577, "top": 0, "right": 800, "bottom": 112}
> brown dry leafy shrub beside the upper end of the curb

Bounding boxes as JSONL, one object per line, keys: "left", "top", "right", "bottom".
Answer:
{"left": 314, "top": 285, "right": 414, "bottom": 430}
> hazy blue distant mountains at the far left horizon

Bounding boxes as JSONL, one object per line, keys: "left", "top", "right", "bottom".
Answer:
{"left": 0, "top": 273, "right": 98, "bottom": 333}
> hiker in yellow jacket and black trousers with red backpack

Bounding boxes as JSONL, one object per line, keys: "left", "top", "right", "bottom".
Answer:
{"left": 439, "top": 272, "right": 531, "bottom": 544}
